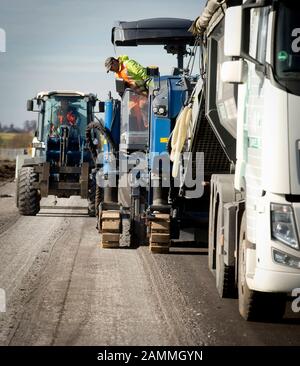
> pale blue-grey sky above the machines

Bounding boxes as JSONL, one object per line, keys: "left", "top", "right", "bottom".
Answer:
{"left": 0, "top": 0, "right": 205, "bottom": 126}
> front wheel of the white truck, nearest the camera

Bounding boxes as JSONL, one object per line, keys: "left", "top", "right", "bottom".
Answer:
{"left": 238, "top": 213, "right": 286, "bottom": 321}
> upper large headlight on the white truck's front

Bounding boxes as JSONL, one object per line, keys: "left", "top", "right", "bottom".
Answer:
{"left": 271, "top": 203, "right": 299, "bottom": 249}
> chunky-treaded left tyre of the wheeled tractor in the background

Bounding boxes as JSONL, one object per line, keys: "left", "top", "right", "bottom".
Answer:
{"left": 17, "top": 167, "right": 40, "bottom": 216}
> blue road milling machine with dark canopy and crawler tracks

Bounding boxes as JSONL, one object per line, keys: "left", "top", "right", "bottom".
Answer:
{"left": 87, "top": 18, "right": 210, "bottom": 253}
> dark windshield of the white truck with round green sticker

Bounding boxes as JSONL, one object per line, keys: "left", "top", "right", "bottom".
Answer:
{"left": 274, "top": 0, "right": 300, "bottom": 81}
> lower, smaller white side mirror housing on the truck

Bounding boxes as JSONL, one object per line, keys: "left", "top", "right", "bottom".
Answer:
{"left": 221, "top": 59, "right": 248, "bottom": 84}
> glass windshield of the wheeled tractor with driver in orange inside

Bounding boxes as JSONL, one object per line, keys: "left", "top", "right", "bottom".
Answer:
{"left": 43, "top": 96, "right": 87, "bottom": 141}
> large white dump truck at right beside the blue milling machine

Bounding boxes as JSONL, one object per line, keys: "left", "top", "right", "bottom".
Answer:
{"left": 183, "top": 0, "right": 300, "bottom": 321}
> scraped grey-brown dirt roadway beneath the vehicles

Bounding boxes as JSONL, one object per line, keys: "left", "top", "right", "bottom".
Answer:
{"left": 0, "top": 182, "right": 300, "bottom": 346}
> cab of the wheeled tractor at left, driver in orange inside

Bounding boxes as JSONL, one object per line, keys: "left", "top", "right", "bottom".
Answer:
{"left": 29, "top": 92, "right": 96, "bottom": 166}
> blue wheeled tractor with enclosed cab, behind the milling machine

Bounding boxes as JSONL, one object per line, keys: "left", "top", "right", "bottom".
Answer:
{"left": 16, "top": 91, "right": 102, "bottom": 216}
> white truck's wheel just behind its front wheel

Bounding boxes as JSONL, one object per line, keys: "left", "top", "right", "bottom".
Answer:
{"left": 216, "top": 203, "right": 236, "bottom": 298}
